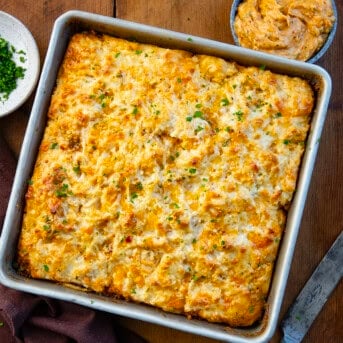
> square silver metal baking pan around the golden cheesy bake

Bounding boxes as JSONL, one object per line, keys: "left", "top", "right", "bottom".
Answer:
{"left": 0, "top": 11, "right": 331, "bottom": 342}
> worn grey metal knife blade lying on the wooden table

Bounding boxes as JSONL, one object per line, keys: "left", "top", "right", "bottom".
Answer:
{"left": 281, "top": 231, "right": 343, "bottom": 343}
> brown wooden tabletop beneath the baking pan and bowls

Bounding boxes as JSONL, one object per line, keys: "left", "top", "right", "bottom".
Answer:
{"left": 0, "top": 0, "right": 343, "bottom": 343}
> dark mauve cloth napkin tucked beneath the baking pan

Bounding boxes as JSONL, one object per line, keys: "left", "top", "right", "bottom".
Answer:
{"left": 0, "top": 136, "right": 145, "bottom": 343}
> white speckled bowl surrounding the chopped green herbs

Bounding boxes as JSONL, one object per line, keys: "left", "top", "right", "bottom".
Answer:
{"left": 0, "top": 11, "right": 40, "bottom": 117}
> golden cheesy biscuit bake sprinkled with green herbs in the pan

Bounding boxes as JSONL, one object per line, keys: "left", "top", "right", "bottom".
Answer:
{"left": 17, "top": 32, "right": 314, "bottom": 326}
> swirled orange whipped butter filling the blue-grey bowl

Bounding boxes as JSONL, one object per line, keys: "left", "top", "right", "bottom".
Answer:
{"left": 234, "top": 0, "right": 336, "bottom": 61}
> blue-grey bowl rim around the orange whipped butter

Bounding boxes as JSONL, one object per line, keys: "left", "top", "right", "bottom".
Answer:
{"left": 230, "top": 0, "right": 338, "bottom": 63}
